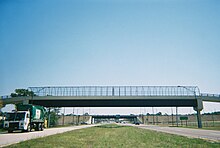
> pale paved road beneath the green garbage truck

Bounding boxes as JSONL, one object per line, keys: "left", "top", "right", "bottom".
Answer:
{"left": 0, "top": 125, "right": 97, "bottom": 147}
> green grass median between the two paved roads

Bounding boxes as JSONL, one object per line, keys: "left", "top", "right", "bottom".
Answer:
{"left": 5, "top": 124, "right": 220, "bottom": 148}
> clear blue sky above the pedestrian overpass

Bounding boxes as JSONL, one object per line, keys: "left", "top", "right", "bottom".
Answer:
{"left": 0, "top": 0, "right": 220, "bottom": 114}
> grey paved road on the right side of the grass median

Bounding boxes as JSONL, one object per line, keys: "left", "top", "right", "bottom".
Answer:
{"left": 137, "top": 125, "right": 220, "bottom": 142}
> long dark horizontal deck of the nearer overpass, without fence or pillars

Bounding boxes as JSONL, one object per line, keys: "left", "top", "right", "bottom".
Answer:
{"left": 3, "top": 96, "right": 197, "bottom": 107}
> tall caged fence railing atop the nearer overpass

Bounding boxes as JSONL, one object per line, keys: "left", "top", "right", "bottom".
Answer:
{"left": 29, "top": 86, "right": 200, "bottom": 96}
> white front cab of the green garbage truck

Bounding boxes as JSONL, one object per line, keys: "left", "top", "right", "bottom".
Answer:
{"left": 3, "top": 111, "right": 31, "bottom": 133}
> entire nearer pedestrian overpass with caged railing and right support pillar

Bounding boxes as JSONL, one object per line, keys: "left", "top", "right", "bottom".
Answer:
{"left": 2, "top": 86, "right": 220, "bottom": 127}
